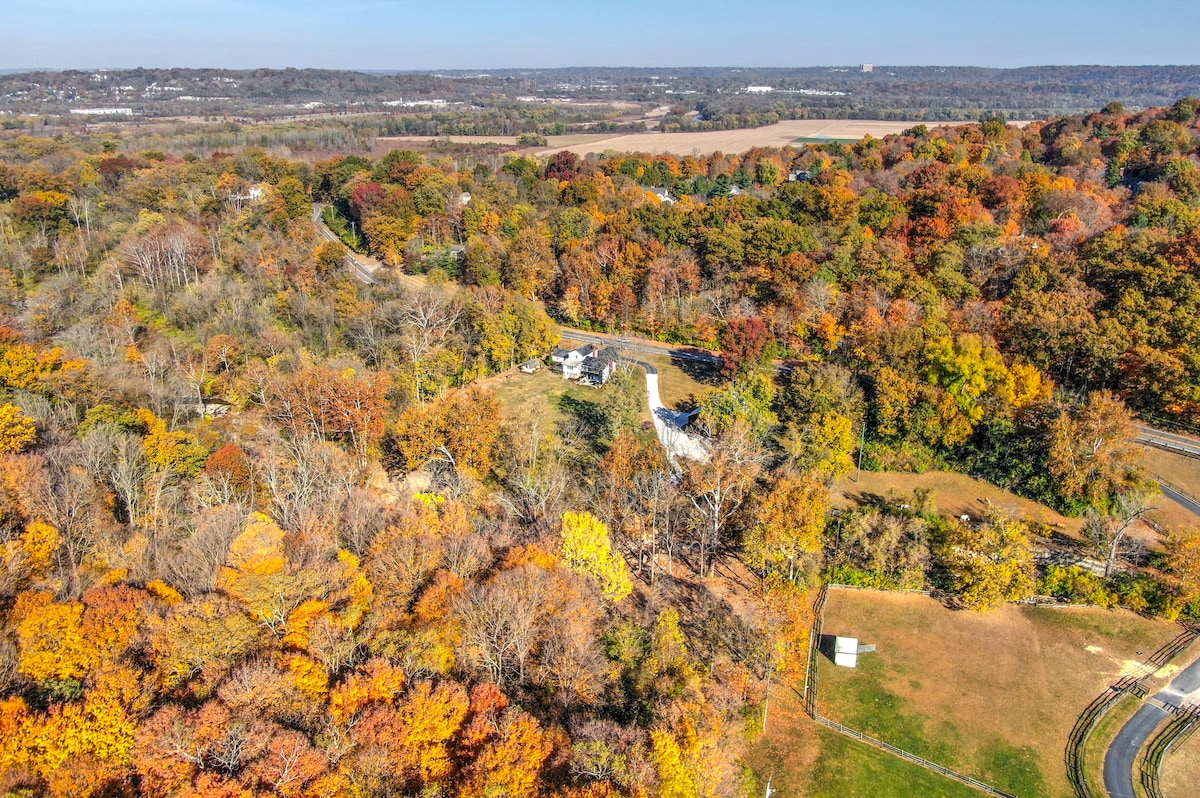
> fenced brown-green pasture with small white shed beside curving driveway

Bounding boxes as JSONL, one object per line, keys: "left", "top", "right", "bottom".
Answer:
{"left": 820, "top": 590, "right": 1177, "bottom": 798}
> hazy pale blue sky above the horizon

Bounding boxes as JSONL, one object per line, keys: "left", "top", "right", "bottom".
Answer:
{"left": 7, "top": 0, "right": 1200, "bottom": 70}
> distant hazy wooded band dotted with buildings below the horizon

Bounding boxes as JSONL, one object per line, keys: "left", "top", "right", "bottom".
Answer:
{"left": 0, "top": 65, "right": 1200, "bottom": 123}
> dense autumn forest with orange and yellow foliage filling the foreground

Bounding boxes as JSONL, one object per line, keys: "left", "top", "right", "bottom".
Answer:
{"left": 0, "top": 98, "right": 1200, "bottom": 798}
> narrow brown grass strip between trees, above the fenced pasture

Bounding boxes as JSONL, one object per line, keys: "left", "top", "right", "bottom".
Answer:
{"left": 832, "top": 472, "right": 1084, "bottom": 538}
